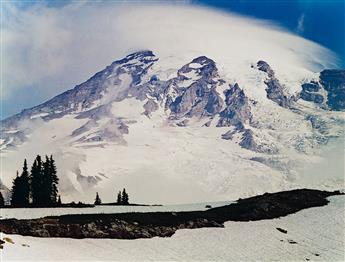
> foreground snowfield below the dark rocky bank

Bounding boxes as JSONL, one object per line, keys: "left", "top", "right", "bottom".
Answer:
{"left": 0, "top": 196, "right": 345, "bottom": 261}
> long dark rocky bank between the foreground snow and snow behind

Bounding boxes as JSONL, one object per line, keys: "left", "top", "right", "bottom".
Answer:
{"left": 0, "top": 189, "right": 341, "bottom": 239}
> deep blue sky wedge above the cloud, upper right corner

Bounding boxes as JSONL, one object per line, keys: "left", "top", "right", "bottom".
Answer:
{"left": 192, "top": 0, "right": 345, "bottom": 64}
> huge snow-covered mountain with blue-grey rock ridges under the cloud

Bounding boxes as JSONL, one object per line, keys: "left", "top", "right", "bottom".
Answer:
{"left": 1, "top": 51, "right": 345, "bottom": 202}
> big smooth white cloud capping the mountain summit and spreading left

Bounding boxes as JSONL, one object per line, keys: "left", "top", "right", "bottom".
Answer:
{"left": 1, "top": 2, "right": 333, "bottom": 107}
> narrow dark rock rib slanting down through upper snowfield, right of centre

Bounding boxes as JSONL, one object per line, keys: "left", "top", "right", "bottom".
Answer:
{"left": 257, "top": 60, "right": 294, "bottom": 108}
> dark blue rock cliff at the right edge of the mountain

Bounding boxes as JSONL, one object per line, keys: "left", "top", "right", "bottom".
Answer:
{"left": 320, "top": 70, "right": 345, "bottom": 110}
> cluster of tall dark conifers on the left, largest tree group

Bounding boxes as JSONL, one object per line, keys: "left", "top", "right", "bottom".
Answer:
{"left": 9, "top": 155, "right": 61, "bottom": 207}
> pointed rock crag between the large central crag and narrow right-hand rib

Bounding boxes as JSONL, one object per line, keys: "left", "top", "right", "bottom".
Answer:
{"left": 217, "top": 83, "right": 252, "bottom": 127}
